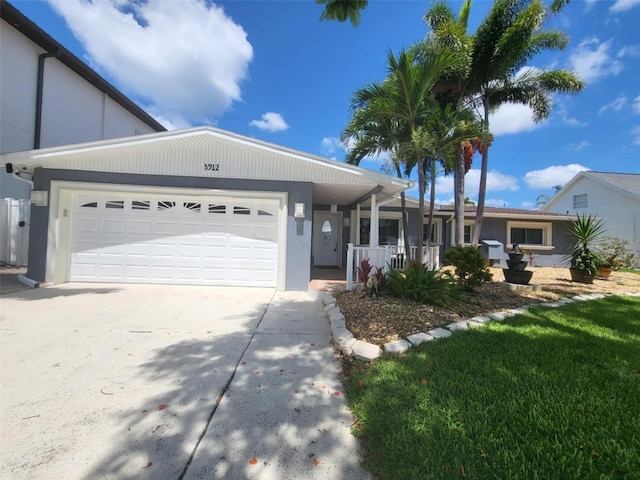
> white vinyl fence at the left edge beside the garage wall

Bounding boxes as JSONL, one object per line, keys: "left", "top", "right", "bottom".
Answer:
{"left": 0, "top": 198, "right": 31, "bottom": 267}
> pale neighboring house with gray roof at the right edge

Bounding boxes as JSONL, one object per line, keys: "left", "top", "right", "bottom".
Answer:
{"left": 543, "top": 171, "right": 640, "bottom": 262}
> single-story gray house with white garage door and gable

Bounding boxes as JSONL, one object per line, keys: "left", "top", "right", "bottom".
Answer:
{"left": 0, "top": 127, "right": 571, "bottom": 290}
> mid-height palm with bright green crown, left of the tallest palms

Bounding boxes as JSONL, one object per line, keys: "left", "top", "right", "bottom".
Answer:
{"left": 344, "top": 50, "right": 457, "bottom": 262}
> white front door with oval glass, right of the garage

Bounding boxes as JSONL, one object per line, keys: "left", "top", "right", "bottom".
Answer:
{"left": 313, "top": 212, "right": 342, "bottom": 267}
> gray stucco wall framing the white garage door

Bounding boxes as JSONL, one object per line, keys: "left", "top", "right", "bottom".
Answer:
{"left": 27, "top": 168, "right": 313, "bottom": 291}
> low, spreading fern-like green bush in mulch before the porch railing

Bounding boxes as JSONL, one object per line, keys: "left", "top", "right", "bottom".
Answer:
{"left": 386, "top": 261, "right": 458, "bottom": 307}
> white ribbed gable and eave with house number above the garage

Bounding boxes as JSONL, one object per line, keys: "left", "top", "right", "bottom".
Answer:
{"left": 0, "top": 127, "right": 413, "bottom": 205}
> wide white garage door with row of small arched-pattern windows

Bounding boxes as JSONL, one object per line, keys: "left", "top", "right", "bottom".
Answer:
{"left": 69, "top": 192, "right": 279, "bottom": 287}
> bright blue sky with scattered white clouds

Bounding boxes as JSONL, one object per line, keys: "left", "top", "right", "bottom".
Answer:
{"left": 12, "top": 0, "right": 640, "bottom": 208}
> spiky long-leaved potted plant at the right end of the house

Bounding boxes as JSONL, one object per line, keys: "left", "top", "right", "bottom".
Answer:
{"left": 568, "top": 215, "right": 605, "bottom": 283}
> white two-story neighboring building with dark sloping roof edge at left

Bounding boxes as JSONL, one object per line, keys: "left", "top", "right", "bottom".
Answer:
{"left": 0, "top": 0, "right": 166, "bottom": 199}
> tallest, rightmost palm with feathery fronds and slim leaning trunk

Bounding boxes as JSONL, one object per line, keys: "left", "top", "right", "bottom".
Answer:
{"left": 465, "top": 0, "right": 583, "bottom": 244}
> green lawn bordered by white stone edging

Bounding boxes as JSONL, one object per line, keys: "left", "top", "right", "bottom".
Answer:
{"left": 346, "top": 297, "right": 640, "bottom": 480}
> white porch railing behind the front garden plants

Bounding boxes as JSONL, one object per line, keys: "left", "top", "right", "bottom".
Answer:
{"left": 347, "top": 243, "right": 440, "bottom": 290}
